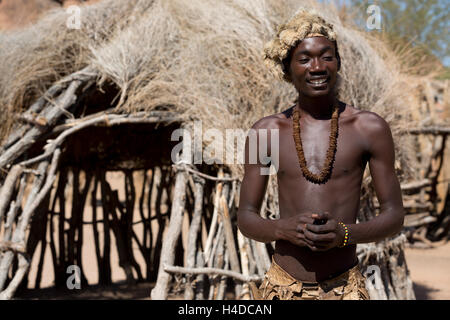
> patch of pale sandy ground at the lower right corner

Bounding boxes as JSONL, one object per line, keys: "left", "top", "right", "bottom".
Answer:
{"left": 405, "top": 242, "right": 450, "bottom": 300}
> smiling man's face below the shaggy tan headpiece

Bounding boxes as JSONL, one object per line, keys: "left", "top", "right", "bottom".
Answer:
{"left": 289, "top": 37, "right": 338, "bottom": 97}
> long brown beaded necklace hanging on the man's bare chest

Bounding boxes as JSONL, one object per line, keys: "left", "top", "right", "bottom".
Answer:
{"left": 292, "top": 106, "right": 339, "bottom": 184}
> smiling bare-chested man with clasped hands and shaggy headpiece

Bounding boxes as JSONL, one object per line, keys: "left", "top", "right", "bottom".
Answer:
{"left": 238, "top": 11, "right": 404, "bottom": 300}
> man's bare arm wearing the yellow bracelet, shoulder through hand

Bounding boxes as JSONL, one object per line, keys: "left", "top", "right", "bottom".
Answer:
{"left": 304, "top": 113, "right": 404, "bottom": 251}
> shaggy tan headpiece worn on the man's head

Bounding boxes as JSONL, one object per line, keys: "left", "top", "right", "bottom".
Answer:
{"left": 264, "top": 9, "right": 340, "bottom": 82}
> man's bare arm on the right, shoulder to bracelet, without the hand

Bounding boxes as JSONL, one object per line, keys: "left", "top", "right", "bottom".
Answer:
{"left": 348, "top": 113, "right": 404, "bottom": 244}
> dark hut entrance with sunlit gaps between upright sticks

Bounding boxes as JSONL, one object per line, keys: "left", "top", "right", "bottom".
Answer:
{"left": 1, "top": 118, "right": 191, "bottom": 296}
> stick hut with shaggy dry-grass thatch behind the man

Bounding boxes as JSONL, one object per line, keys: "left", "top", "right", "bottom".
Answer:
{"left": 0, "top": 0, "right": 448, "bottom": 299}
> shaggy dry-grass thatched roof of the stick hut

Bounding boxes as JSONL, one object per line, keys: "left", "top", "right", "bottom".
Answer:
{"left": 0, "top": 0, "right": 442, "bottom": 178}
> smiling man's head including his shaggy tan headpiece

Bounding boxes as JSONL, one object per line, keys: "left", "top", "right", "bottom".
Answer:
{"left": 264, "top": 10, "right": 341, "bottom": 96}
